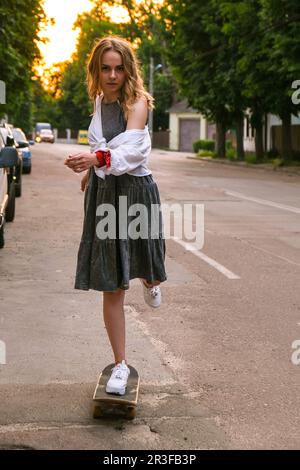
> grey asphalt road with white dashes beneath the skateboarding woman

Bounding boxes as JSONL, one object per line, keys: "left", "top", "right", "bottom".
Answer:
{"left": 0, "top": 144, "right": 300, "bottom": 449}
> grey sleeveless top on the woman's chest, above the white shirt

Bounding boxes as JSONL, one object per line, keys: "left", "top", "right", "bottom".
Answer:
{"left": 101, "top": 100, "right": 149, "bottom": 142}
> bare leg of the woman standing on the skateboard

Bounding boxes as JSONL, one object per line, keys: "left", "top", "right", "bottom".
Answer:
{"left": 103, "top": 289, "right": 125, "bottom": 364}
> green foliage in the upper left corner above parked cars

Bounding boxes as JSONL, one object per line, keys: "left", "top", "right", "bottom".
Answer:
{"left": 0, "top": 0, "right": 46, "bottom": 132}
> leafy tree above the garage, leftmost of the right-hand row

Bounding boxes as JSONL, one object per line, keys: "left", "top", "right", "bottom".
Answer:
{"left": 162, "top": 0, "right": 243, "bottom": 158}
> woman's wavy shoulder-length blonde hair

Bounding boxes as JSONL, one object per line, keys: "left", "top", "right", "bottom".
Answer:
{"left": 87, "top": 36, "right": 154, "bottom": 120}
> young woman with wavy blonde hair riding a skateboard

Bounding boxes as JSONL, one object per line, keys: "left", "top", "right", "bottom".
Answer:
{"left": 65, "top": 36, "right": 167, "bottom": 395}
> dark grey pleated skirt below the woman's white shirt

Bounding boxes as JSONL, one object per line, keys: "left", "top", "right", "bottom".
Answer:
{"left": 74, "top": 168, "right": 167, "bottom": 291}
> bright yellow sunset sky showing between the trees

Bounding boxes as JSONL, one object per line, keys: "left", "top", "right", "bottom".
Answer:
{"left": 39, "top": 0, "right": 128, "bottom": 68}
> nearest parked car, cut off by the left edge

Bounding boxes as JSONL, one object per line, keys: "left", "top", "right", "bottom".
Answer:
{"left": 0, "top": 134, "right": 19, "bottom": 248}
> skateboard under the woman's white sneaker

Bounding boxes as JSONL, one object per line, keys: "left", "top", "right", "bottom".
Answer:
{"left": 93, "top": 364, "right": 140, "bottom": 419}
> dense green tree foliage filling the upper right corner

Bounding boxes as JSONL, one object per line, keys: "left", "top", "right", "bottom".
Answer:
{"left": 163, "top": 0, "right": 300, "bottom": 157}
